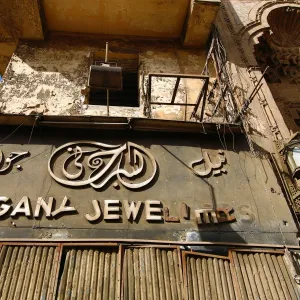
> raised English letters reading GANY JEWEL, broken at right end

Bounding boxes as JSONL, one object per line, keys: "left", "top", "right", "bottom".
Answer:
{"left": 0, "top": 196, "right": 235, "bottom": 225}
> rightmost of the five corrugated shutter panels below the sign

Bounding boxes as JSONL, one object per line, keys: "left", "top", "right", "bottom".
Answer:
{"left": 230, "top": 250, "right": 300, "bottom": 300}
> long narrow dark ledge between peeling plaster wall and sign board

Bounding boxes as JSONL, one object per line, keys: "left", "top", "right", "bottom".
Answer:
{"left": 0, "top": 115, "right": 242, "bottom": 134}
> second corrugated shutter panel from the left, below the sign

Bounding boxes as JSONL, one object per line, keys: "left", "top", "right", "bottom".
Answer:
{"left": 57, "top": 247, "right": 120, "bottom": 300}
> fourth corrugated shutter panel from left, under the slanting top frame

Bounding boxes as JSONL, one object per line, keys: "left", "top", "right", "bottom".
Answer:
{"left": 183, "top": 252, "right": 236, "bottom": 300}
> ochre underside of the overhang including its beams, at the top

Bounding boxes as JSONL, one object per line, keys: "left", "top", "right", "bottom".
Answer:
{"left": 0, "top": 0, "right": 221, "bottom": 47}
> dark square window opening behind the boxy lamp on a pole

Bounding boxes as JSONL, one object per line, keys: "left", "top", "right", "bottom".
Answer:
{"left": 89, "top": 52, "right": 139, "bottom": 107}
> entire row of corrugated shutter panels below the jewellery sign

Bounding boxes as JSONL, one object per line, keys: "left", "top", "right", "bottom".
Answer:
{"left": 0, "top": 243, "right": 300, "bottom": 300}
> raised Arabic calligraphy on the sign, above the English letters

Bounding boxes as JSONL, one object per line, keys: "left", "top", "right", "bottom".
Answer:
{"left": 0, "top": 141, "right": 227, "bottom": 180}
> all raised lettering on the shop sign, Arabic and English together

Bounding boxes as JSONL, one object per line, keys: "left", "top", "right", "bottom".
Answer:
{"left": 0, "top": 141, "right": 235, "bottom": 225}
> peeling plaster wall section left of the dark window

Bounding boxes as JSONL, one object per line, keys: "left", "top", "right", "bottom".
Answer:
{"left": 0, "top": 45, "right": 88, "bottom": 115}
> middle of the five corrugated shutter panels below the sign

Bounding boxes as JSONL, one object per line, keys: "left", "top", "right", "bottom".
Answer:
{"left": 123, "top": 247, "right": 183, "bottom": 300}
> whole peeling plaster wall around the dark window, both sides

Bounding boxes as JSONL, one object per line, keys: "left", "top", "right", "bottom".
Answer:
{"left": 0, "top": 35, "right": 211, "bottom": 120}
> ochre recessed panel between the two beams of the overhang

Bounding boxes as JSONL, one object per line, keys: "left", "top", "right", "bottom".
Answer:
{"left": 43, "top": 0, "right": 190, "bottom": 38}
